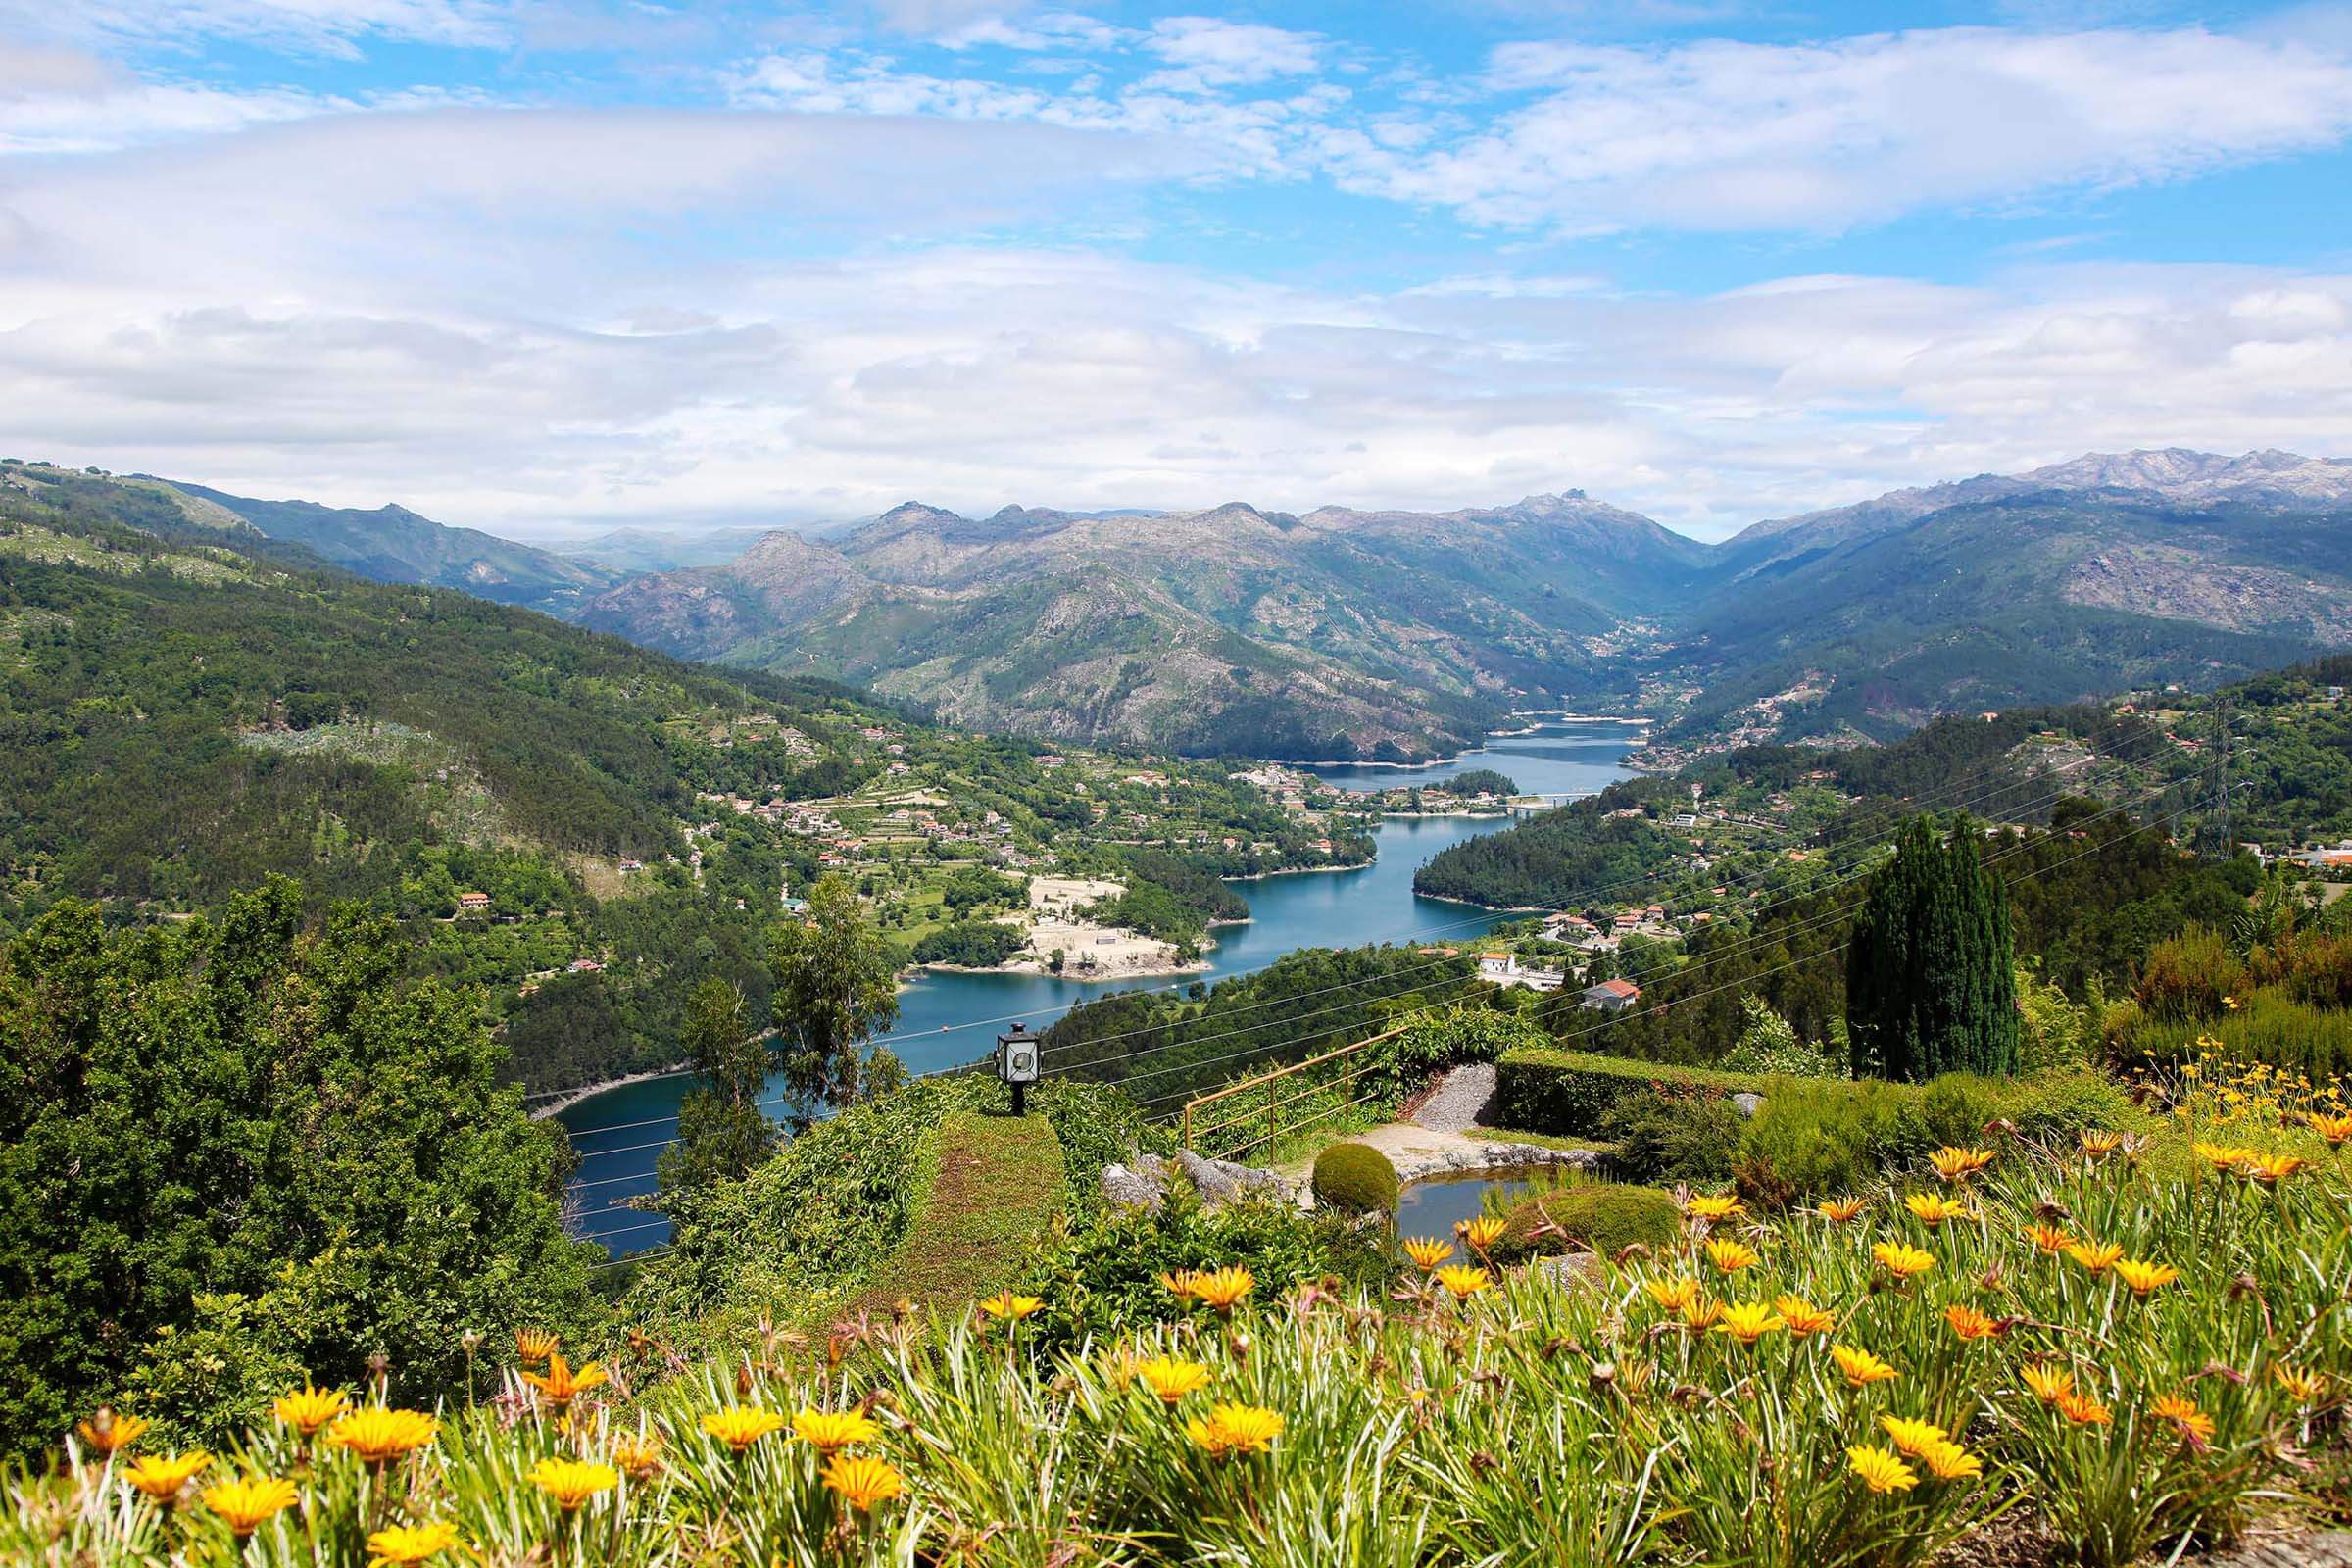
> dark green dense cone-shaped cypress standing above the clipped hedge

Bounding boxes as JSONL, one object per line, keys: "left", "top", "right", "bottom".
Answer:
{"left": 1846, "top": 815, "right": 2018, "bottom": 1081}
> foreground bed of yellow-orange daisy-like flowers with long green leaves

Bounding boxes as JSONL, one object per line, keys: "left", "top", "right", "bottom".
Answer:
{"left": 14, "top": 1091, "right": 2352, "bottom": 1568}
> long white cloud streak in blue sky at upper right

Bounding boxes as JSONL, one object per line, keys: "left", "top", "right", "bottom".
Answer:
{"left": 1331, "top": 28, "right": 2352, "bottom": 230}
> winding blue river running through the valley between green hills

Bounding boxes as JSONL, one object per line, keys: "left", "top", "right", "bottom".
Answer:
{"left": 558, "top": 724, "right": 1642, "bottom": 1253}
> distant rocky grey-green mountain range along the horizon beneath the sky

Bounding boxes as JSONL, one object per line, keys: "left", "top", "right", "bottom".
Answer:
{"left": 74, "top": 449, "right": 2352, "bottom": 761}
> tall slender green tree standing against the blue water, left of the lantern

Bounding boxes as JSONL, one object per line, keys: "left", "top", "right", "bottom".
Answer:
{"left": 769, "top": 877, "right": 899, "bottom": 1131}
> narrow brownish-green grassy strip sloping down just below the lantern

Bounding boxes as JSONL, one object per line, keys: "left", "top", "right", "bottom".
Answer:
{"left": 849, "top": 1109, "right": 1063, "bottom": 1316}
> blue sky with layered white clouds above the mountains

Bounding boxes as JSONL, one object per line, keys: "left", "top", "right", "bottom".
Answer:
{"left": 0, "top": 0, "right": 2352, "bottom": 536}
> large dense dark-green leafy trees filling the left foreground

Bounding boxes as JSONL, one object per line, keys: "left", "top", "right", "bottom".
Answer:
{"left": 0, "top": 879, "right": 600, "bottom": 1455}
